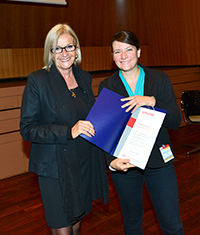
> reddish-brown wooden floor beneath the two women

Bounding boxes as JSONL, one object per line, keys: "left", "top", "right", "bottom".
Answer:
{"left": 0, "top": 127, "right": 200, "bottom": 235}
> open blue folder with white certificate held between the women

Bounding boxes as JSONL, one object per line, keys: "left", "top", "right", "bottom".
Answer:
{"left": 81, "top": 88, "right": 166, "bottom": 169}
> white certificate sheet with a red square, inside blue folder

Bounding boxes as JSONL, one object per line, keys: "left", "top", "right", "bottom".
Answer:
{"left": 114, "top": 107, "right": 166, "bottom": 169}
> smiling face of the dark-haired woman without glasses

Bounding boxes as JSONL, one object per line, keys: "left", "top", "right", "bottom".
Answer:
{"left": 112, "top": 41, "right": 140, "bottom": 72}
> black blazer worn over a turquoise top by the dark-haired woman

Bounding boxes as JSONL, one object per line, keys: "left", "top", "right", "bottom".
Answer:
{"left": 99, "top": 65, "right": 181, "bottom": 168}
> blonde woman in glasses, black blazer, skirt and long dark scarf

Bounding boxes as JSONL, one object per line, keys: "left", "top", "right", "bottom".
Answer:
{"left": 20, "top": 24, "right": 108, "bottom": 235}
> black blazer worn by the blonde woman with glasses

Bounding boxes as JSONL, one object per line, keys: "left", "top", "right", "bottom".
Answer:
{"left": 20, "top": 66, "right": 95, "bottom": 178}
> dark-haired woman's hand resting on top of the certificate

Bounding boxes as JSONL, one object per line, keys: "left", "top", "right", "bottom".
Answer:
{"left": 121, "top": 95, "right": 156, "bottom": 113}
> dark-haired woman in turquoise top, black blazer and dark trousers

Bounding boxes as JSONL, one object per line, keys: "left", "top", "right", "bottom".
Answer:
{"left": 99, "top": 31, "right": 184, "bottom": 235}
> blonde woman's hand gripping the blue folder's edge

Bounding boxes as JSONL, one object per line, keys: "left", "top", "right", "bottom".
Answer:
{"left": 71, "top": 120, "right": 95, "bottom": 139}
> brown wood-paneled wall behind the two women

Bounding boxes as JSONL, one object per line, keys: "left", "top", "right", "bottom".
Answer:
{"left": 0, "top": 0, "right": 200, "bottom": 179}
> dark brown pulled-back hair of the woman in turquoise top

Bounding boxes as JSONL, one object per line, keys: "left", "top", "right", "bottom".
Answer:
{"left": 111, "top": 30, "right": 140, "bottom": 52}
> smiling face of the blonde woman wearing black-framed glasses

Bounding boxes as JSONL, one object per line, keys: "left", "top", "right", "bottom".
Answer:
{"left": 52, "top": 33, "right": 77, "bottom": 73}
